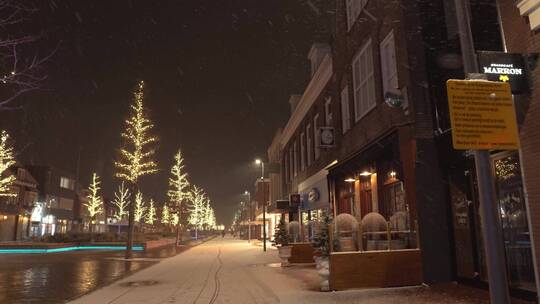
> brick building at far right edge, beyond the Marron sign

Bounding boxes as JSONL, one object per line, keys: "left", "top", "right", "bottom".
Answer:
{"left": 498, "top": 0, "right": 540, "bottom": 296}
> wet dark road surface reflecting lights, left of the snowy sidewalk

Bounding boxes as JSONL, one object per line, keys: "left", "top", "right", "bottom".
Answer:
{"left": 0, "top": 246, "right": 185, "bottom": 304}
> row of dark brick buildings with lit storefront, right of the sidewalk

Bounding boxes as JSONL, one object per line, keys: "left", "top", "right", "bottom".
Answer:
{"left": 272, "top": 0, "right": 538, "bottom": 297}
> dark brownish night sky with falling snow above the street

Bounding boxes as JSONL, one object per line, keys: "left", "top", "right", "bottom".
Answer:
{"left": 0, "top": 0, "right": 331, "bottom": 223}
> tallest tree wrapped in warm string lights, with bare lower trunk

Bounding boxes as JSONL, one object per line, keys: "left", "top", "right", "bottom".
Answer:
{"left": 115, "top": 81, "right": 157, "bottom": 258}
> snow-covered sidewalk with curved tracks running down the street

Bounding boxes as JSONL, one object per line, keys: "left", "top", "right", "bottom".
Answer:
{"left": 66, "top": 238, "right": 526, "bottom": 304}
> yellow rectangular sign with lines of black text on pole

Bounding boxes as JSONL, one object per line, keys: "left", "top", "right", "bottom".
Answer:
{"left": 446, "top": 80, "right": 519, "bottom": 150}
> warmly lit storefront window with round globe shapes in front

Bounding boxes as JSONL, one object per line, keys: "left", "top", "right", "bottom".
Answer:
{"left": 335, "top": 161, "right": 417, "bottom": 251}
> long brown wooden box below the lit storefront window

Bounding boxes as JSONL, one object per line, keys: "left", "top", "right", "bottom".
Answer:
{"left": 330, "top": 249, "right": 423, "bottom": 290}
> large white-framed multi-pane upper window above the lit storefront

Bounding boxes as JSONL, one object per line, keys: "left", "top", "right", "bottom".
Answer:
{"left": 352, "top": 39, "right": 377, "bottom": 121}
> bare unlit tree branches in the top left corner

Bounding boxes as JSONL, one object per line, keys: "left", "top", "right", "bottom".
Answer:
{"left": 0, "top": 0, "right": 54, "bottom": 111}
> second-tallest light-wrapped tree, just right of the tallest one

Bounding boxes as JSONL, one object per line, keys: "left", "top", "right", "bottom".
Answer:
{"left": 167, "top": 150, "right": 191, "bottom": 243}
